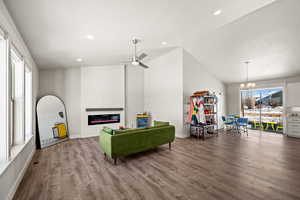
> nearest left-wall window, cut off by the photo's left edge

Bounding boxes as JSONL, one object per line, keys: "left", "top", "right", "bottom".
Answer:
{"left": 0, "top": 29, "right": 9, "bottom": 162}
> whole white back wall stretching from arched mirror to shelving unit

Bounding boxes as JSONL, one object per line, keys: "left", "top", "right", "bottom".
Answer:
{"left": 39, "top": 48, "right": 225, "bottom": 137}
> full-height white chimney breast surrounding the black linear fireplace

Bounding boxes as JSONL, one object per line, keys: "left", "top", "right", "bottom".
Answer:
{"left": 81, "top": 65, "right": 125, "bottom": 137}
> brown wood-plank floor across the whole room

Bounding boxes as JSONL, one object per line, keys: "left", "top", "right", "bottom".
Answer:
{"left": 14, "top": 131, "right": 300, "bottom": 200}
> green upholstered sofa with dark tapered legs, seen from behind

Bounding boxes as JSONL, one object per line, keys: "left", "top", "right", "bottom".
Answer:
{"left": 99, "top": 125, "right": 175, "bottom": 164}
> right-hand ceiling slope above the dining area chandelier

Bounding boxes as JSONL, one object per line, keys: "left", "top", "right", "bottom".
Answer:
{"left": 184, "top": 0, "right": 300, "bottom": 83}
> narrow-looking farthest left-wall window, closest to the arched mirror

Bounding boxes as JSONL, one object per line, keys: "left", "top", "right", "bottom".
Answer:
{"left": 25, "top": 65, "right": 33, "bottom": 141}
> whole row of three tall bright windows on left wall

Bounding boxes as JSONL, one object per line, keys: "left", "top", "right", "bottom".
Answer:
{"left": 0, "top": 28, "right": 33, "bottom": 164}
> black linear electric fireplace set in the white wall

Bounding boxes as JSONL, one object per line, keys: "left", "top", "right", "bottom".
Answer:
{"left": 88, "top": 114, "right": 120, "bottom": 126}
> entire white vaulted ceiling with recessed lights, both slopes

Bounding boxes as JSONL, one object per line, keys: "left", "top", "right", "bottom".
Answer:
{"left": 4, "top": 0, "right": 300, "bottom": 82}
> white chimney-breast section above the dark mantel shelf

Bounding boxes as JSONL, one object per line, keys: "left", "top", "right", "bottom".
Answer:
{"left": 81, "top": 65, "right": 125, "bottom": 109}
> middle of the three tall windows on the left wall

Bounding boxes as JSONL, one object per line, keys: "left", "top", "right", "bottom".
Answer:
{"left": 10, "top": 48, "right": 25, "bottom": 147}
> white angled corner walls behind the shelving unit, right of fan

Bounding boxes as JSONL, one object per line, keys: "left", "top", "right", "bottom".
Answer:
{"left": 144, "top": 48, "right": 226, "bottom": 137}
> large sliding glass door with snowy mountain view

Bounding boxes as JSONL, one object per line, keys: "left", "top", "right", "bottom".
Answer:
{"left": 241, "top": 88, "right": 283, "bottom": 133}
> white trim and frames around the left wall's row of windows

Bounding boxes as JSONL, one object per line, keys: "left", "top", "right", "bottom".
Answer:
{"left": 0, "top": 25, "right": 35, "bottom": 166}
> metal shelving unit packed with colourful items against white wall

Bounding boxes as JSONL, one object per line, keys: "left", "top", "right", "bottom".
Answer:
{"left": 189, "top": 95, "right": 218, "bottom": 140}
